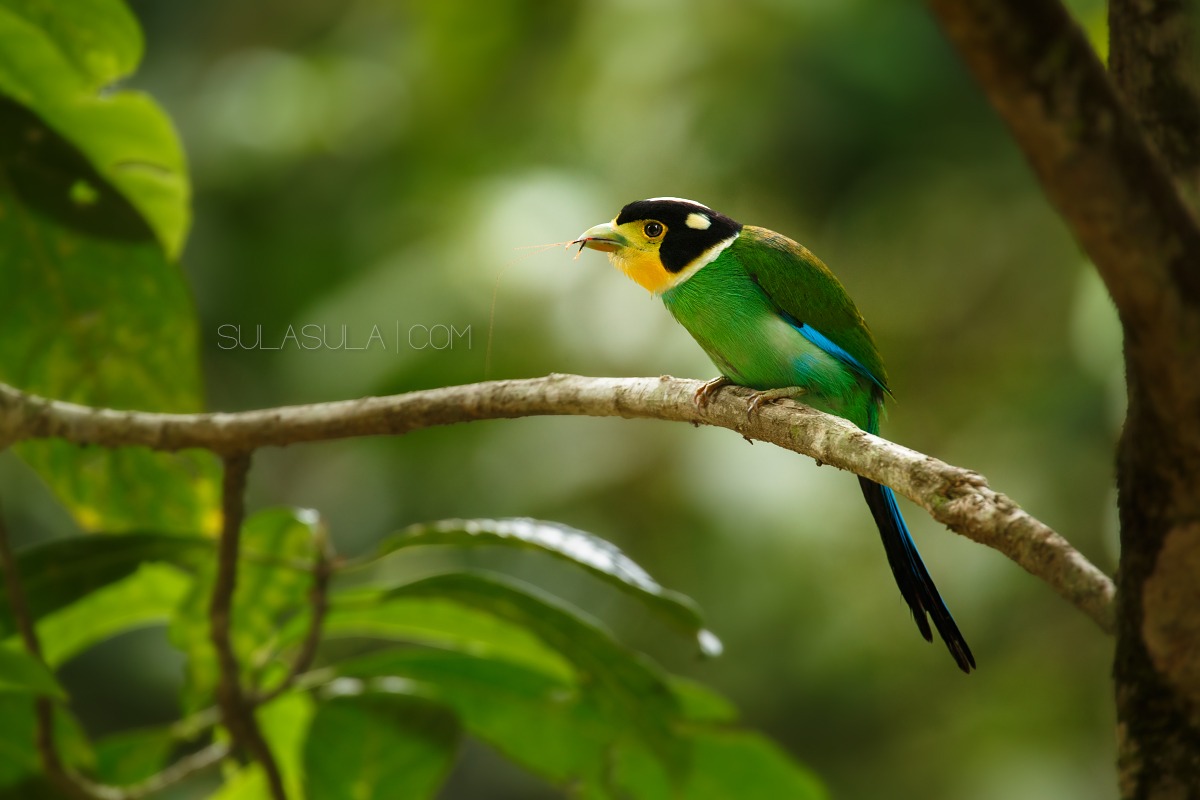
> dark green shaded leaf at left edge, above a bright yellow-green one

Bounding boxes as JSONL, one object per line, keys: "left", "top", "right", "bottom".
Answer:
{"left": 0, "top": 534, "right": 214, "bottom": 646}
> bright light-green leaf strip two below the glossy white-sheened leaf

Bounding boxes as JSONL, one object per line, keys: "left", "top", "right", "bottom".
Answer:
{"left": 291, "top": 589, "right": 575, "bottom": 680}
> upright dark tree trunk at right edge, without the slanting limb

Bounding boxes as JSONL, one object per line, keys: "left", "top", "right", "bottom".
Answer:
{"left": 1109, "top": 0, "right": 1200, "bottom": 800}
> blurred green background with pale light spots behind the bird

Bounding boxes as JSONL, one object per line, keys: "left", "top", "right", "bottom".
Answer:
{"left": 0, "top": 0, "right": 1124, "bottom": 800}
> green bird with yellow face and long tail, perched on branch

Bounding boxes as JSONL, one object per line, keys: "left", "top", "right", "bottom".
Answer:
{"left": 574, "top": 197, "right": 974, "bottom": 672}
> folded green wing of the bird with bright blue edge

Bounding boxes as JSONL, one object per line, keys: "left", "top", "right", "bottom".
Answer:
{"left": 733, "top": 225, "right": 892, "bottom": 393}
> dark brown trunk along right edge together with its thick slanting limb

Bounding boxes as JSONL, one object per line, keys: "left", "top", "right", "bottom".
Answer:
{"left": 930, "top": 0, "right": 1200, "bottom": 800}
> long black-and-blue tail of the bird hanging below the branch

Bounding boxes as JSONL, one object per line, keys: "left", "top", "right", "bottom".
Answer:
{"left": 858, "top": 477, "right": 976, "bottom": 673}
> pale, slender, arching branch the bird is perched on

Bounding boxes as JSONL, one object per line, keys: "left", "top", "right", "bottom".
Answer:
{"left": 0, "top": 375, "right": 1114, "bottom": 633}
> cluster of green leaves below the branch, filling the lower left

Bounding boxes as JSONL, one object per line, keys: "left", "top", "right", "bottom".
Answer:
{"left": 0, "top": 509, "right": 824, "bottom": 800}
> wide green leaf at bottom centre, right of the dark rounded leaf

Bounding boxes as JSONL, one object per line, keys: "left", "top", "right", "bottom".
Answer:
{"left": 337, "top": 649, "right": 824, "bottom": 800}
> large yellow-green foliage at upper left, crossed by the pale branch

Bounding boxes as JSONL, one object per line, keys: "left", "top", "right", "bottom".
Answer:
{"left": 0, "top": 0, "right": 214, "bottom": 531}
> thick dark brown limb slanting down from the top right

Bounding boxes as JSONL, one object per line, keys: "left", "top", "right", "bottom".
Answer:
{"left": 929, "top": 0, "right": 1200, "bottom": 379}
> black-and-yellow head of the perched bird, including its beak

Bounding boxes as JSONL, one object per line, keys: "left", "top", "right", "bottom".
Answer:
{"left": 572, "top": 197, "right": 742, "bottom": 294}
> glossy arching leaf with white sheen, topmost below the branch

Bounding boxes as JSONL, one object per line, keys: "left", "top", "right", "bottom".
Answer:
{"left": 378, "top": 518, "right": 721, "bottom": 656}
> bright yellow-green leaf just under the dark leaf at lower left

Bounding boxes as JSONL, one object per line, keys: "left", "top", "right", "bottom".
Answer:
{"left": 37, "top": 564, "right": 192, "bottom": 667}
